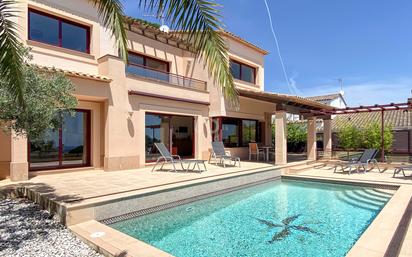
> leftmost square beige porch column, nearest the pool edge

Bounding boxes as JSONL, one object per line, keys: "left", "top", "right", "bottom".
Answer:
{"left": 275, "top": 111, "right": 288, "bottom": 165}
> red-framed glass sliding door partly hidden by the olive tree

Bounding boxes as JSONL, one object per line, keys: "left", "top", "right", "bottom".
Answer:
{"left": 28, "top": 110, "right": 90, "bottom": 170}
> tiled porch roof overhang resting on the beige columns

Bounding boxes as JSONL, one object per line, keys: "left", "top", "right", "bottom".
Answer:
{"left": 237, "top": 89, "right": 333, "bottom": 116}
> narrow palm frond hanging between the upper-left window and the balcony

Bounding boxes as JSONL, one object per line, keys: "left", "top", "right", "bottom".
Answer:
{"left": 89, "top": 0, "right": 127, "bottom": 62}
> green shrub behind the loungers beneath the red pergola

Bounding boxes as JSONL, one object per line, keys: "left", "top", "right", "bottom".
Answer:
{"left": 361, "top": 123, "right": 393, "bottom": 151}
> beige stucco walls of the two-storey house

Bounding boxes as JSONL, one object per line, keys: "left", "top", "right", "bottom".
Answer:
{"left": 0, "top": 0, "right": 275, "bottom": 179}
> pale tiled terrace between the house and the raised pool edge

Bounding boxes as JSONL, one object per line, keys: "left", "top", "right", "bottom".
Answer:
{"left": 0, "top": 162, "right": 279, "bottom": 208}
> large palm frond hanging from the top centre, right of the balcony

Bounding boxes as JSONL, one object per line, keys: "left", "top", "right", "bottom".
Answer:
{"left": 140, "top": 0, "right": 238, "bottom": 106}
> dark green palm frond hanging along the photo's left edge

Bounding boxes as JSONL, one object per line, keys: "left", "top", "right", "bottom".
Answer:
{"left": 0, "top": 0, "right": 24, "bottom": 106}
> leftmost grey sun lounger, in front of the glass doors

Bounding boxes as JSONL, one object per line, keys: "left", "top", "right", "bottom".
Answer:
{"left": 152, "top": 143, "right": 207, "bottom": 173}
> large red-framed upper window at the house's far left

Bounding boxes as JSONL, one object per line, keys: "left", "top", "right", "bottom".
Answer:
{"left": 29, "top": 9, "right": 90, "bottom": 53}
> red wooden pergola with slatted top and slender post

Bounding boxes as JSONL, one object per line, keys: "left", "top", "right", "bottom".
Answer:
{"left": 302, "top": 98, "right": 412, "bottom": 162}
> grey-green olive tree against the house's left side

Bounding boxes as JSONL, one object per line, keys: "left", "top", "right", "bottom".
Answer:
{"left": 0, "top": 60, "right": 77, "bottom": 140}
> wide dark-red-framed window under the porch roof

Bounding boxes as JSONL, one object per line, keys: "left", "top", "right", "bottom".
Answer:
{"left": 212, "top": 117, "right": 262, "bottom": 147}
